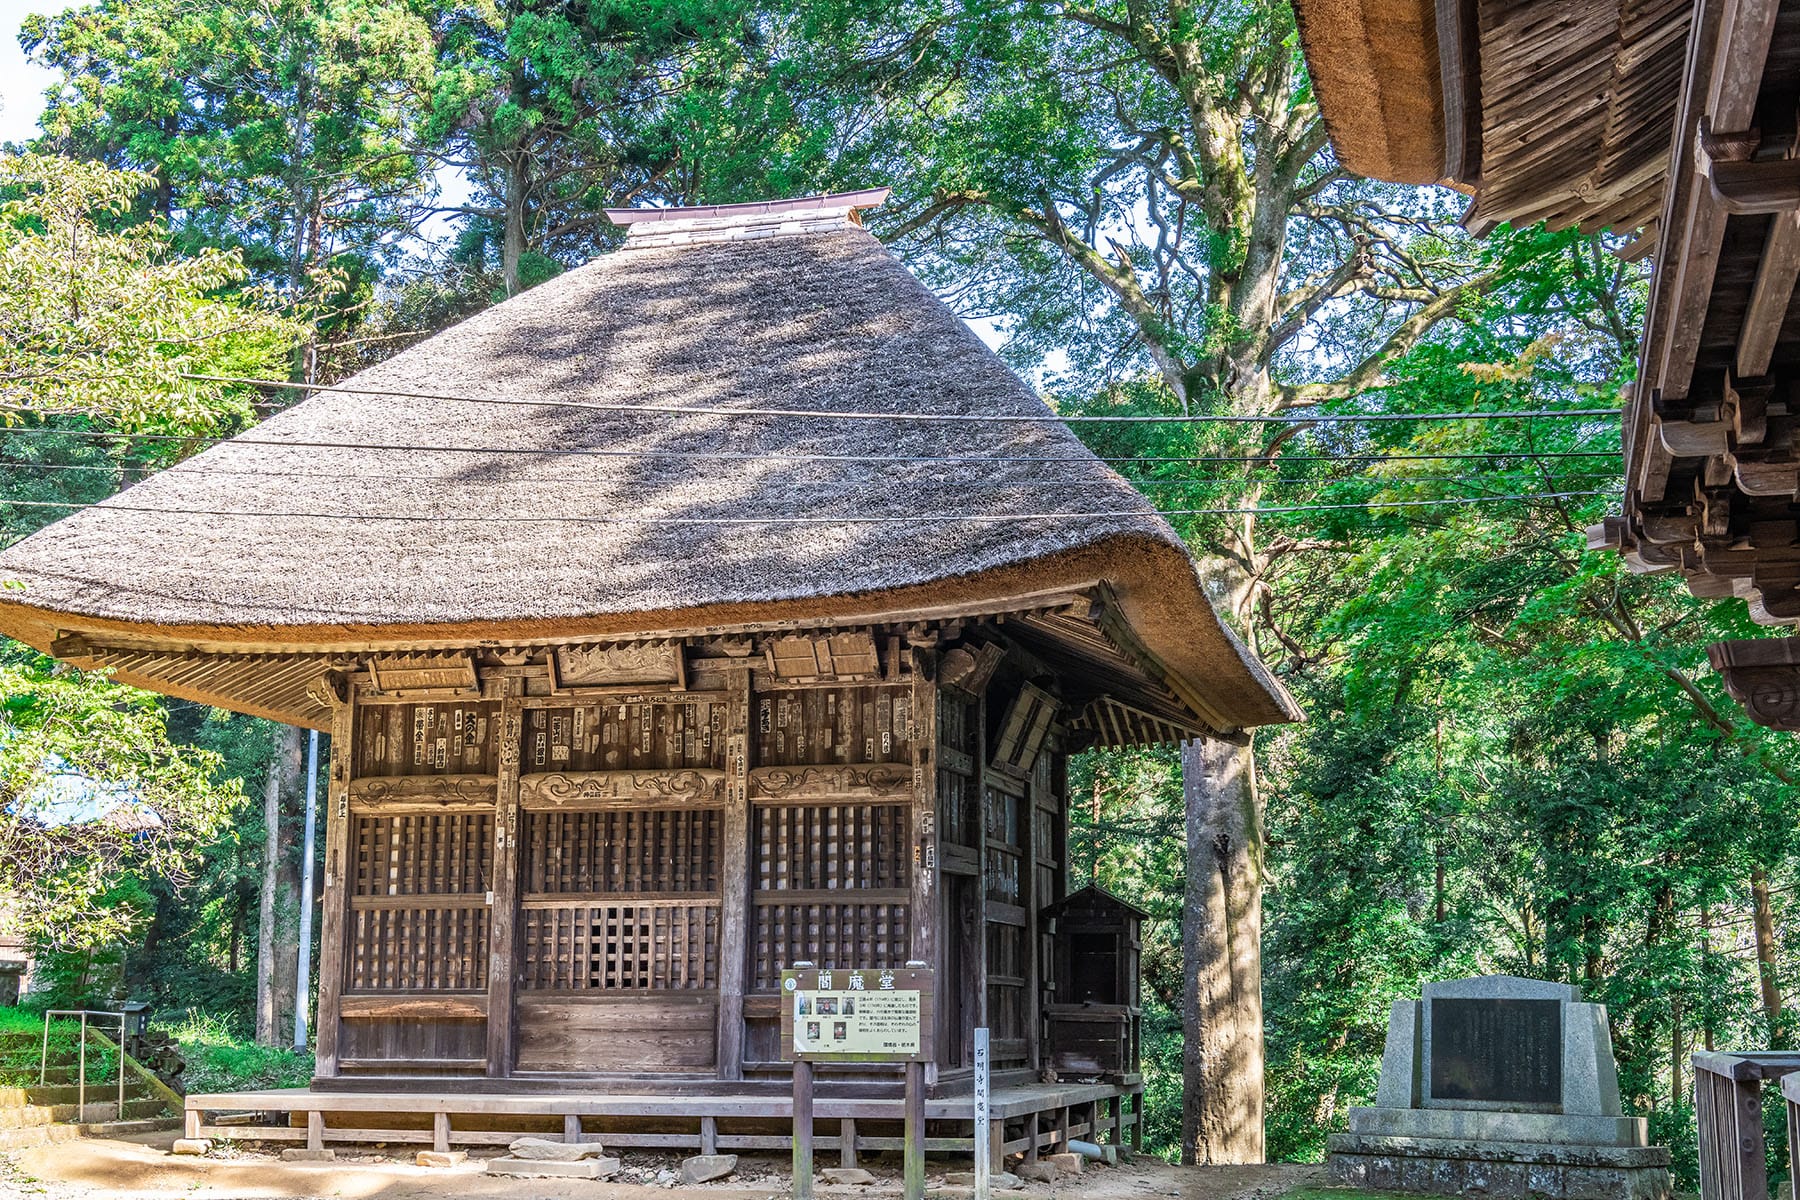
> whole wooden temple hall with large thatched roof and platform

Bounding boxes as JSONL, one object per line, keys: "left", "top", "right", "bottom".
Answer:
{"left": 0, "top": 193, "right": 1298, "bottom": 1155}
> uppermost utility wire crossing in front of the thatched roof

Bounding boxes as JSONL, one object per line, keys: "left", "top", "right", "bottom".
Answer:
{"left": 7, "top": 371, "right": 1622, "bottom": 425}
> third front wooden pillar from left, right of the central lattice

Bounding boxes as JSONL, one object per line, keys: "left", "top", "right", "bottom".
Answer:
{"left": 706, "top": 669, "right": 751, "bottom": 1086}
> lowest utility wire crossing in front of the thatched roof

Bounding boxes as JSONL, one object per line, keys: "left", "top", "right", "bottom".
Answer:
{"left": 0, "top": 491, "right": 1615, "bottom": 525}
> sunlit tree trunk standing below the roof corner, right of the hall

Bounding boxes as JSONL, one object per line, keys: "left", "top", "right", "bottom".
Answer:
{"left": 1181, "top": 738, "right": 1264, "bottom": 1164}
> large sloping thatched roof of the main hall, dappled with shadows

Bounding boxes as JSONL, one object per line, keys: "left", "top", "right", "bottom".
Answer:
{"left": 0, "top": 193, "right": 1296, "bottom": 737}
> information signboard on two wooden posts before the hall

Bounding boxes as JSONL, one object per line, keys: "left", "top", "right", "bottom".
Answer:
{"left": 781, "top": 963, "right": 934, "bottom": 1200}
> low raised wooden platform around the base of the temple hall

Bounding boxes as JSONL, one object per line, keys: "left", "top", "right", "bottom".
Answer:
{"left": 185, "top": 1078, "right": 1143, "bottom": 1164}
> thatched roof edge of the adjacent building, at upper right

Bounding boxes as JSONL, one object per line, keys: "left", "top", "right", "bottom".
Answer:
{"left": 1296, "top": 0, "right": 1694, "bottom": 241}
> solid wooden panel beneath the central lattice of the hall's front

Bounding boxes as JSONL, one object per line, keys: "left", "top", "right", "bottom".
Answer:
{"left": 518, "top": 993, "right": 718, "bottom": 1074}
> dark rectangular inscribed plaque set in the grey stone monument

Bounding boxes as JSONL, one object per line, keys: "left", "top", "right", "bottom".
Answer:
{"left": 1431, "top": 999, "right": 1562, "bottom": 1105}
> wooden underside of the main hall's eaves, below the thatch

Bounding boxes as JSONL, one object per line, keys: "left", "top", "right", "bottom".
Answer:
{"left": 45, "top": 583, "right": 1237, "bottom": 747}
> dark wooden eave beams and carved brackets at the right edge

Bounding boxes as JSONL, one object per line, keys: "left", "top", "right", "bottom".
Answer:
{"left": 1589, "top": 0, "right": 1800, "bottom": 729}
